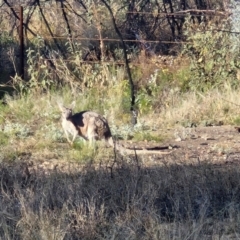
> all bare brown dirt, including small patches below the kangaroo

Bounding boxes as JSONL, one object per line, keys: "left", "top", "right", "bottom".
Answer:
{"left": 24, "top": 126, "right": 240, "bottom": 174}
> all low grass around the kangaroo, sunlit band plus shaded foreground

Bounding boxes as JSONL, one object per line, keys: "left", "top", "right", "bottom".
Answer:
{"left": 0, "top": 75, "right": 240, "bottom": 239}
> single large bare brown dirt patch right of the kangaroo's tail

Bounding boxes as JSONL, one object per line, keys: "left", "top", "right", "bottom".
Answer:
{"left": 124, "top": 125, "right": 240, "bottom": 165}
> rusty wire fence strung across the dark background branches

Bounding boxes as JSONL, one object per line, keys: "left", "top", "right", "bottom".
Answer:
{"left": 0, "top": 3, "right": 237, "bottom": 81}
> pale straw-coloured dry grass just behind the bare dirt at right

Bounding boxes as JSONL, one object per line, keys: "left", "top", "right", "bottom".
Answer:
{"left": 158, "top": 82, "right": 240, "bottom": 125}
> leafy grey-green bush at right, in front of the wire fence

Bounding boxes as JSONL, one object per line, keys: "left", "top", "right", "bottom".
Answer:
{"left": 182, "top": 18, "right": 240, "bottom": 91}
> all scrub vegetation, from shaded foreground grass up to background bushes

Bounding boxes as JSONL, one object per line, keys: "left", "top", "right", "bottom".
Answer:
{"left": 0, "top": 1, "right": 240, "bottom": 240}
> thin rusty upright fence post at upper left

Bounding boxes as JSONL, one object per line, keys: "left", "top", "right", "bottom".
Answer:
{"left": 19, "top": 6, "right": 24, "bottom": 79}
